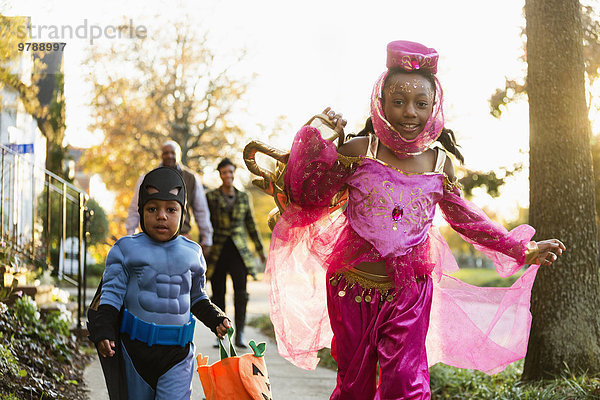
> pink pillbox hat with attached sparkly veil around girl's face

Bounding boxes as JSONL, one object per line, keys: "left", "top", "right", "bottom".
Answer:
{"left": 371, "top": 40, "right": 444, "bottom": 158}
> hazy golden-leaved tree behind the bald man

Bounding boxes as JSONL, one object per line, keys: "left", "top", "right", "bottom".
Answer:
{"left": 84, "top": 23, "right": 251, "bottom": 231}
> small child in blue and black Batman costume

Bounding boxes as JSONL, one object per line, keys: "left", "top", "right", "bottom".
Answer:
{"left": 88, "top": 167, "right": 231, "bottom": 400}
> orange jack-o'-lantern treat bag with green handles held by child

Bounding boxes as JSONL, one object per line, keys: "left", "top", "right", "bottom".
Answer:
{"left": 196, "top": 328, "right": 272, "bottom": 400}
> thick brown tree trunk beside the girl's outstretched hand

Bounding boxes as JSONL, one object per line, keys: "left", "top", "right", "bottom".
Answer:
{"left": 523, "top": 0, "right": 600, "bottom": 380}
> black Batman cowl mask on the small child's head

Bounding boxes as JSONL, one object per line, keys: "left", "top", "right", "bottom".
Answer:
{"left": 138, "top": 167, "right": 186, "bottom": 238}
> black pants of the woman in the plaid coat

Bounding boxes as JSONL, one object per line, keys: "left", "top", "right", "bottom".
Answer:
{"left": 210, "top": 238, "right": 248, "bottom": 332}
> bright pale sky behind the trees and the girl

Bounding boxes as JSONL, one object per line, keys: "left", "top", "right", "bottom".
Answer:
{"left": 7, "top": 0, "right": 528, "bottom": 219}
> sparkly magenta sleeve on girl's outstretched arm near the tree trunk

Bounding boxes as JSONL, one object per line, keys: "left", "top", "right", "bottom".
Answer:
{"left": 439, "top": 185, "right": 535, "bottom": 277}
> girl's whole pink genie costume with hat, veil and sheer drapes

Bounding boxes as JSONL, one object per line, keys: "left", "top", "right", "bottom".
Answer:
{"left": 266, "top": 42, "right": 538, "bottom": 399}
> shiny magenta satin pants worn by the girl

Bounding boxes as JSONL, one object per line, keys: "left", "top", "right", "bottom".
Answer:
{"left": 327, "top": 270, "right": 433, "bottom": 400}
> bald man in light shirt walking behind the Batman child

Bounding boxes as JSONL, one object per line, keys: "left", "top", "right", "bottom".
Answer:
{"left": 125, "top": 140, "right": 213, "bottom": 247}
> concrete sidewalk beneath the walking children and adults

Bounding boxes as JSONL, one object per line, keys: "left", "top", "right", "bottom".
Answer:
{"left": 84, "top": 280, "right": 336, "bottom": 400}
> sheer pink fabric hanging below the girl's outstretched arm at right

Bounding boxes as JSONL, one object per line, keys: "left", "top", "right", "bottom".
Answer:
{"left": 426, "top": 228, "right": 539, "bottom": 375}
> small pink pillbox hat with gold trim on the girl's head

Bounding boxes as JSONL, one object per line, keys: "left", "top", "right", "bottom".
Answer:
{"left": 386, "top": 40, "right": 439, "bottom": 74}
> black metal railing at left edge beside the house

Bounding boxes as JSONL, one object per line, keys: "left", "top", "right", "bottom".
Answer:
{"left": 0, "top": 145, "right": 89, "bottom": 326}
